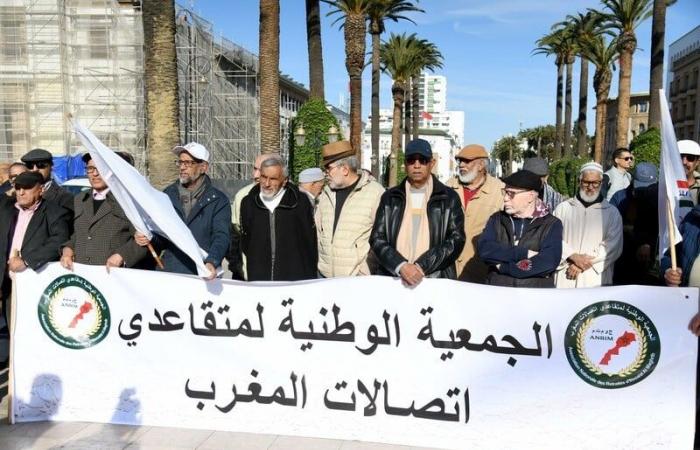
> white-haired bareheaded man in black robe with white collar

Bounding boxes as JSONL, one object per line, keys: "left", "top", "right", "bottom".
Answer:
{"left": 241, "top": 156, "right": 318, "bottom": 281}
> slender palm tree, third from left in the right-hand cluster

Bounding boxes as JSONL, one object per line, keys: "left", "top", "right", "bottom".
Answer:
{"left": 559, "top": 10, "right": 603, "bottom": 156}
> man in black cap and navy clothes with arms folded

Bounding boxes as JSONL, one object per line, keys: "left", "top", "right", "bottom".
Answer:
{"left": 477, "top": 170, "right": 562, "bottom": 288}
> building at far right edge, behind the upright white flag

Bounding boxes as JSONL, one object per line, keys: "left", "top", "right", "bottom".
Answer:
{"left": 666, "top": 26, "right": 700, "bottom": 142}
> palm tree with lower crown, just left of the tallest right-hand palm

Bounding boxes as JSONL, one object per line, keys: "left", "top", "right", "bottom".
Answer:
{"left": 581, "top": 35, "right": 619, "bottom": 163}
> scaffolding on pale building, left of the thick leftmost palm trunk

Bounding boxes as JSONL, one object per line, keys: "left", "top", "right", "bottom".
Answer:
{"left": 0, "top": 0, "right": 145, "bottom": 167}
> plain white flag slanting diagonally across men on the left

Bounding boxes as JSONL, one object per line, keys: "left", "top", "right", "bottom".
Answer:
{"left": 73, "top": 120, "right": 209, "bottom": 277}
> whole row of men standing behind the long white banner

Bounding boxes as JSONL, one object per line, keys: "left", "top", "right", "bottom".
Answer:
{"left": 0, "top": 139, "right": 700, "bottom": 311}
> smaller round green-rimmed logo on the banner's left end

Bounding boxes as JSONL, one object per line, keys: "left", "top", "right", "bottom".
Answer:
{"left": 39, "top": 275, "right": 111, "bottom": 350}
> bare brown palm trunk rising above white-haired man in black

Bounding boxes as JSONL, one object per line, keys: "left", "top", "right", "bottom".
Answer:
{"left": 259, "top": 0, "right": 280, "bottom": 153}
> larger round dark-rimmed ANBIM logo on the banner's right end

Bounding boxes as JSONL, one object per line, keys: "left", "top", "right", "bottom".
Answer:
{"left": 564, "top": 301, "right": 661, "bottom": 389}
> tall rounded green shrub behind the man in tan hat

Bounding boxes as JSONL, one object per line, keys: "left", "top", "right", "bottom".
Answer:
{"left": 289, "top": 99, "right": 343, "bottom": 182}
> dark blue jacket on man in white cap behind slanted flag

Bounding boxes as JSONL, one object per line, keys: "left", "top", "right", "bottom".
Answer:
{"left": 159, "top": 175, "right": 231, "bottom": 275}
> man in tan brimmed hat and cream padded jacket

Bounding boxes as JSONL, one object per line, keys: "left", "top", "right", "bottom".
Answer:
{"left": 316, "top": 141, "right": 384, "bottom": 278}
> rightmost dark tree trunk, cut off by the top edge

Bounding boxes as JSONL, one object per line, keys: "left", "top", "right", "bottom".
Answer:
{"left": 649, "top": 0, "right": 666, "bottom": 129}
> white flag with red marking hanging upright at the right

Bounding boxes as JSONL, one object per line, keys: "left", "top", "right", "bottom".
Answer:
{"left": 658, "top": 89, "right": 690, "bottom": 259}
